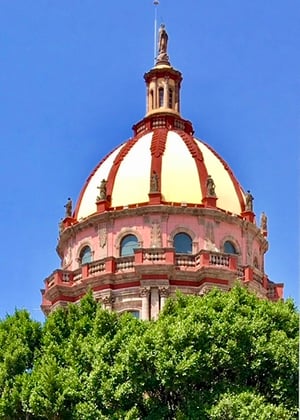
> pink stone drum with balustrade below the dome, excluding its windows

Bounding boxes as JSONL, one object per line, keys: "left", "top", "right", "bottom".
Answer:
{"left": 42, "top": 205, "right": 282, "bottom": 319}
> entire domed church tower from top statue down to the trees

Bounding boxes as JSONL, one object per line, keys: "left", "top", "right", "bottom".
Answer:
{"left": 42, "top": 25, "right": 283, "bottom": 320}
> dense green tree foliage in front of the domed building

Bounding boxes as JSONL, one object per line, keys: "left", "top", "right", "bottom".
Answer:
{"left": 0, "top": 286, "right": 298, "bottom": 420}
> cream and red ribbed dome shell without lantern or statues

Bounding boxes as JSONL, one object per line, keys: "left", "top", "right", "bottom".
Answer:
{"left": 74, "top": 126, "right": 245, "bottom": 220}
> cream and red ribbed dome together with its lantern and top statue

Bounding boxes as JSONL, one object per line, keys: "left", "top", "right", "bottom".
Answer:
{"left": 73, "top": 25, "right": 246, "bottom": 221}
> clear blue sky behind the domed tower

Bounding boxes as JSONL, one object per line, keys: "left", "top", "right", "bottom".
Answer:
{"left": 0, "top": 0, "right": 300, "bottom": 320}
